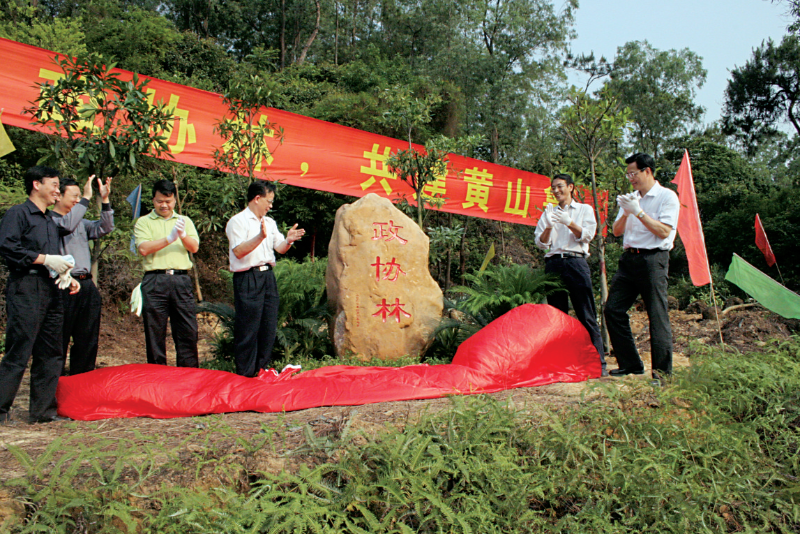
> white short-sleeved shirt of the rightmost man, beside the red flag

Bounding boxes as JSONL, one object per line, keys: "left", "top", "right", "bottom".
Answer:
{"left": 616, "top": 182, "right": 681, "bottom": 250}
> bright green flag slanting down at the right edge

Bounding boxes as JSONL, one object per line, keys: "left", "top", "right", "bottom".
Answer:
{"left": 725, "top": 254, "right": 800, "bottom": 319}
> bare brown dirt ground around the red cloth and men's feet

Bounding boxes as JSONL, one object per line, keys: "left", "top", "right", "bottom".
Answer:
{"left": 0, "top": 307, "right": 798, "bottom": 508}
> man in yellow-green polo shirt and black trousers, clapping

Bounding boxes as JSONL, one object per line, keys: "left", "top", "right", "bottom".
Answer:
{"left": 133, "top": 180, "right": 200, "bottom": 367}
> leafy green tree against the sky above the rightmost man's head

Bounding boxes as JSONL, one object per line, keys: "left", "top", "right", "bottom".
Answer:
{"left": 606, "top": 41, "right": 706, "bottom": 158}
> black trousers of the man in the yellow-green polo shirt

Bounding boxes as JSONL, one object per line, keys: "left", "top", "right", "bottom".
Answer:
{"left": 142, "top": 273, "right": 198, "bottom": 367}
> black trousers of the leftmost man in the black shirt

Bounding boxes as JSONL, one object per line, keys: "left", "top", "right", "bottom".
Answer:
{"left": 0, "top": 274, "right": 64, "bottom": 421}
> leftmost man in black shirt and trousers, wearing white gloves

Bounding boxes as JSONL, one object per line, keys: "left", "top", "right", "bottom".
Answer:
{"left": 0, "top": 166, "right": 80, "bottom": 423}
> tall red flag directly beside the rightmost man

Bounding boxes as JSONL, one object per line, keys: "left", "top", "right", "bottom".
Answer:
{"left": 672, "top": 150, "right": 711, "bottom": 286}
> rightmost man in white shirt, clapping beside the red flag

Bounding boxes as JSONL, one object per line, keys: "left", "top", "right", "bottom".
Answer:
{"left": 605, "top": 152, "right": 680, "bottom": 383}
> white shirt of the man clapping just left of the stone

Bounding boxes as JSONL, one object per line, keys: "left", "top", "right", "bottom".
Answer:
{"left": 225, "top": 207, "right": 285, "bottom": 273}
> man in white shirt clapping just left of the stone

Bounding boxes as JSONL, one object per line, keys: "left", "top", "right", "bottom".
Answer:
{"left": 225, "top": 180, "right": 306, "bottom": 377}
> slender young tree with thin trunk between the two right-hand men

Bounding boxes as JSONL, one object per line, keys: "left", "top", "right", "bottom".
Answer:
{"left": 561, "top": 88, "right": 630, "bottom": 354}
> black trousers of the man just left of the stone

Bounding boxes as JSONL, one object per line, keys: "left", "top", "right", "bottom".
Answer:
{"left": 233, "top": 269, "right": 279, "bottom": 376}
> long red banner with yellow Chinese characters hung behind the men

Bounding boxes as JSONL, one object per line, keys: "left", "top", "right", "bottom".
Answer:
{"left": 0, "top": 39, "right": 607, "bottom": 225}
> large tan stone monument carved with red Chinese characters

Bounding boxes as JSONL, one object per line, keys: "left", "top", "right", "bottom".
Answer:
{"left": 325, "top": 193, "right": 442, "bottom": 360}
